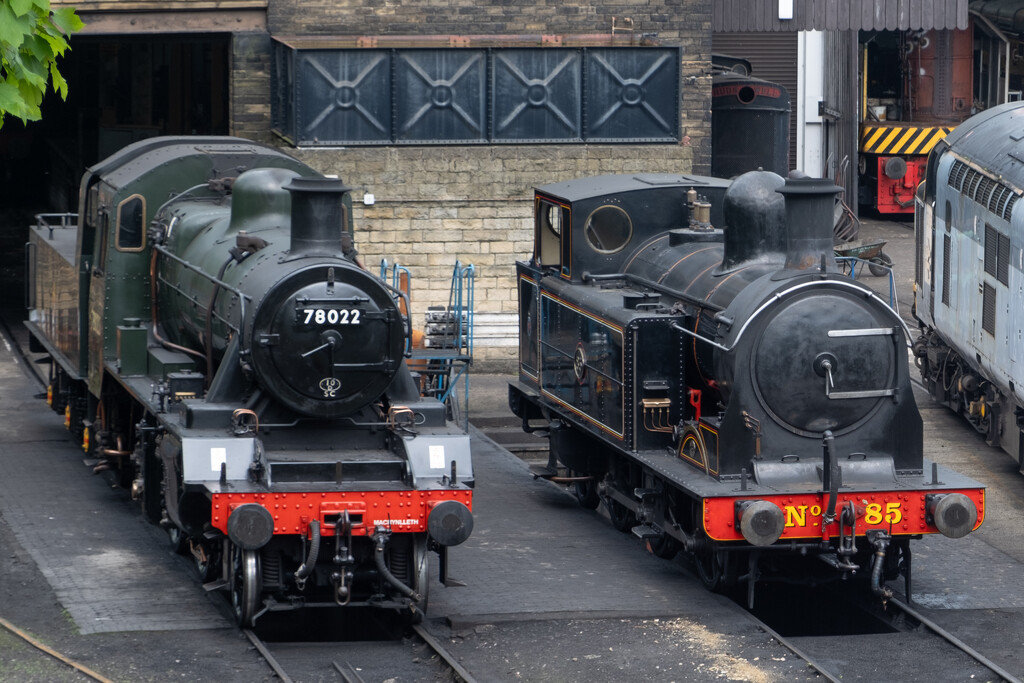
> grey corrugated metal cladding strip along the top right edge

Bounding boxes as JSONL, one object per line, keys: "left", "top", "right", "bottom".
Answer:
{"left": 712, "top": 0, "right": 968, "bottom": 31}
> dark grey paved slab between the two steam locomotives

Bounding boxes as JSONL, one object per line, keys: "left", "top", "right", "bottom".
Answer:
{"left": 428, "top": 428, "right": 719, "bottom": 623}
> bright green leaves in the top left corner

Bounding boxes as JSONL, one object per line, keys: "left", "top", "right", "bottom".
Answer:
{"left": 0, "top": 0, "right": 84, "bottom": 128}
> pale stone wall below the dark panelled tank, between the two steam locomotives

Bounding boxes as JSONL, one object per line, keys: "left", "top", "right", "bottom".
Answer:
{"left": 291, "top": 144, "right": 693, "bottom": 369}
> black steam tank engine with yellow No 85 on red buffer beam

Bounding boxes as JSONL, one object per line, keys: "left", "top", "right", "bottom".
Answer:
{"left": 509, "top": 171, "right": 985, "bottom": 604}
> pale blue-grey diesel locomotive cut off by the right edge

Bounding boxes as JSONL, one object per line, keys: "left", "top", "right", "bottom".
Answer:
{"left": 913, "top": 102, "right": 1024, "bottom": 471}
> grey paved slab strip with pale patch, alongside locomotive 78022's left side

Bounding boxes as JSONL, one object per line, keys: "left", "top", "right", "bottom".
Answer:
{"left": 0, "top": 352, "right": 232, "bottom": 634}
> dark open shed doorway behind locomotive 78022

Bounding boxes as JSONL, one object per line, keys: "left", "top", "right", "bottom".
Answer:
{"left": 0, "top": 34, "right": 230, "bottom": 214}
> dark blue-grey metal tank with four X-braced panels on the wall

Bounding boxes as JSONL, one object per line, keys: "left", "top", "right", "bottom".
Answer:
{"left": 270, "top": 41, "right": 682, "bottom": 146}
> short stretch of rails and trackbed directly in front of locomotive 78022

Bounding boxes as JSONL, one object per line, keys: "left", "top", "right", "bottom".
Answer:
{"left": 243, "top": 625, "right": 476, "bottom": 683}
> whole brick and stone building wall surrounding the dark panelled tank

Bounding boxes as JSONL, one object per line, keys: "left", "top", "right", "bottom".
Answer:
{"left": 231, "top": 0, "right": 712, "bottom": 370}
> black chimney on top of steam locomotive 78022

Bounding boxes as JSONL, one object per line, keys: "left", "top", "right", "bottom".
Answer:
{"left": 285, "top": 178, "right": 352, "bottom": 256}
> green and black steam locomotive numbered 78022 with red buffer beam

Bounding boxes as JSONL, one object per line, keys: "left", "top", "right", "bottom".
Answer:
{"left": 27, "top": 137, "right": 474, "bottom": 626}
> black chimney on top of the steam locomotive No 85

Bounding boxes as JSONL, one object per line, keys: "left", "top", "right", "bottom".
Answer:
{"left": 775, "top": 178, "right": 843, "bottom": 272}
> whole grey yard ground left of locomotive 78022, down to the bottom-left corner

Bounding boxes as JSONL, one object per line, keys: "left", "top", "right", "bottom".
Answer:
{"left": 0, "top": 337, "right": 271, "bottom": 683}
